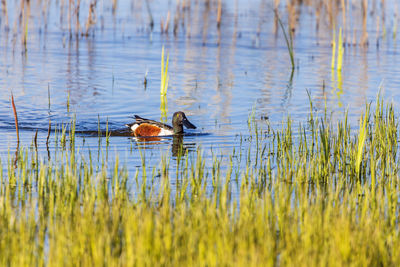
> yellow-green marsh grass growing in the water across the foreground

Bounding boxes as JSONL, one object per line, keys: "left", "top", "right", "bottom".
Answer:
{"left": 0, "top": 98, "right": 400, "bottom": 266}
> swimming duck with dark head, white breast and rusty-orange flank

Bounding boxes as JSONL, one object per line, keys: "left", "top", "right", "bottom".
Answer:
{"left": 126, "top": 111, "right": 196, "bottom": 137}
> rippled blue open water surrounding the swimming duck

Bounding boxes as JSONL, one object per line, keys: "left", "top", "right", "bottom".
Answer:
{"left": 0, "top": 0, "right": 400, "bottom": 178}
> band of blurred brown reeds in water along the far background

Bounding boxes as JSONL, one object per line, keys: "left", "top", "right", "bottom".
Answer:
{"left": 0, "top": 0, "right": 399, "bottom": 49}
